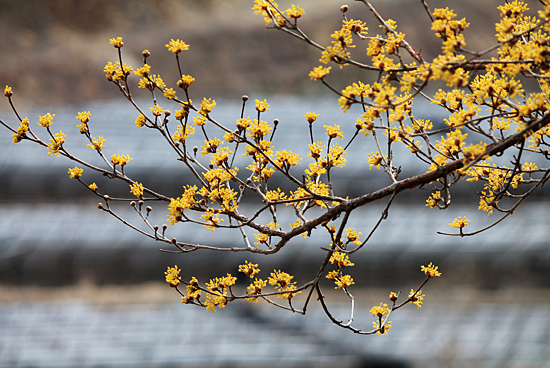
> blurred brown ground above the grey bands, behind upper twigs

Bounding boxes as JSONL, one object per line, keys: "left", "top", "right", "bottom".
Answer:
{"left": 0, "top": 0, "right": 512, "bottom": 106}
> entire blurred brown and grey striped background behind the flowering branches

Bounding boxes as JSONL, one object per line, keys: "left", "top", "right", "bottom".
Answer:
{"left": 0, "top": 0, "right": 550, "bottom": 367}
